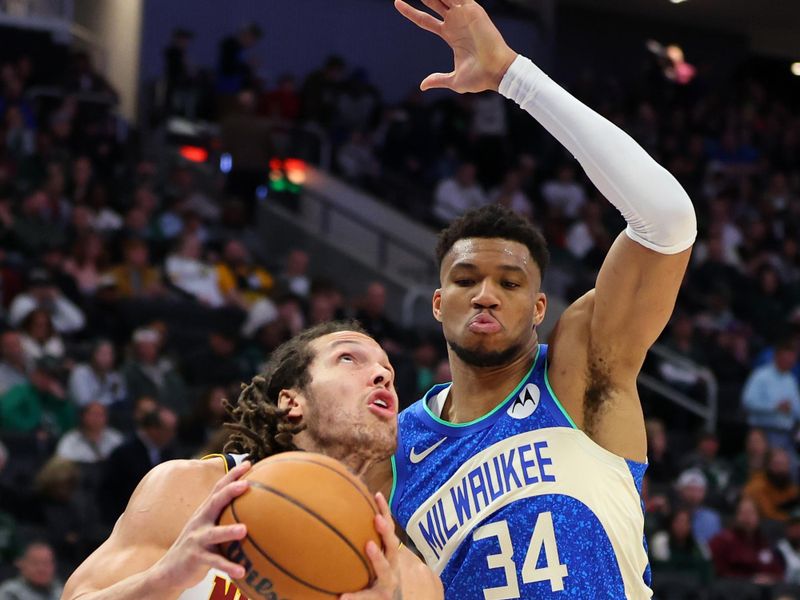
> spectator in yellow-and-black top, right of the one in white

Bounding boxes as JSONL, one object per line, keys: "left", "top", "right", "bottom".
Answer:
{"left": 217, "top": 239, "right": 273, "bottom": 310}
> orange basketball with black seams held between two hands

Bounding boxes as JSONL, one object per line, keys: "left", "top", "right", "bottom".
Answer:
{"left": 219, "top": 452, "right": 381, "bottom": 600}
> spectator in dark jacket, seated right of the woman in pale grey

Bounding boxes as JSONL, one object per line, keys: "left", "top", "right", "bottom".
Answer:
{"left": 122, "top": 328, "right": 188, "bottom": 415}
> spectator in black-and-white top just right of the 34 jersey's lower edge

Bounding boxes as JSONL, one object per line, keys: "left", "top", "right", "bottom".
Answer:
{"left": 650, "top": 509, "right": 712, "bottom": 584}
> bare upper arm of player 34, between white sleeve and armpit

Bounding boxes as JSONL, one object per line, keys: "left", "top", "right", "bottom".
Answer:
{"left": 589, "top": 233, "right": 691, "bottom": 376}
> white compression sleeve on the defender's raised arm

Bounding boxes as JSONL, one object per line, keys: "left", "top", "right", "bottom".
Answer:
{"left": 499, "top": 56, "right": 697, "bottom": 254}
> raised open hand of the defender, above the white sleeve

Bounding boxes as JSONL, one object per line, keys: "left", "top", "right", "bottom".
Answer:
{"left": 394, "top": 0, "right": 517, "bottom": 93}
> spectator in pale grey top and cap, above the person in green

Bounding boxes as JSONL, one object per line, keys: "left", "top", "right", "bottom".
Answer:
{"left": 8, "top": 269, "right": 86, "bottom": 334}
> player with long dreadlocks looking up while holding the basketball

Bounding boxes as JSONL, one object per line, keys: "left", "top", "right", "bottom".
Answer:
{"left": 62, "top": 322, "right": 442, "bottom": 600}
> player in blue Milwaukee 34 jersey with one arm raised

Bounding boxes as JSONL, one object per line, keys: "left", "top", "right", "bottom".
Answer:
{"left": 391, "top": 0, "right": 696, "bottom": 600}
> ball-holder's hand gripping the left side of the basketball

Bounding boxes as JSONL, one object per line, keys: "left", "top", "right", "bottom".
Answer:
{"left": 152, "top": 462, "right": 250, "bottom": 590}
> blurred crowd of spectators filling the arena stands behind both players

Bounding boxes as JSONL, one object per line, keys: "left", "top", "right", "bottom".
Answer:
{"left": 0, "top": 16, "right": 800, "bottom": 600}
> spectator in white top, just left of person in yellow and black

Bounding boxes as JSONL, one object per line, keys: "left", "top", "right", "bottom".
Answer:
{"left": 165, "top": 235, "right": 226, "bottom": 308}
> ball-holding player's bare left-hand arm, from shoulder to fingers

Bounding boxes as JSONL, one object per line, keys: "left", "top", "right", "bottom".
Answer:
{"left": 62, "top": 461, "right": 250, "bottom": 600}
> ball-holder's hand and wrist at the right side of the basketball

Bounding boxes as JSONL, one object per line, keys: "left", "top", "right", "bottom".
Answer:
{"left": 339, "top": 493, "right": 444, "bottom": 600}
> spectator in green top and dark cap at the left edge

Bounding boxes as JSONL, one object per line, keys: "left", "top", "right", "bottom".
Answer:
{"left": 0, "top": 356, "right": 75, "bottom": 437}
